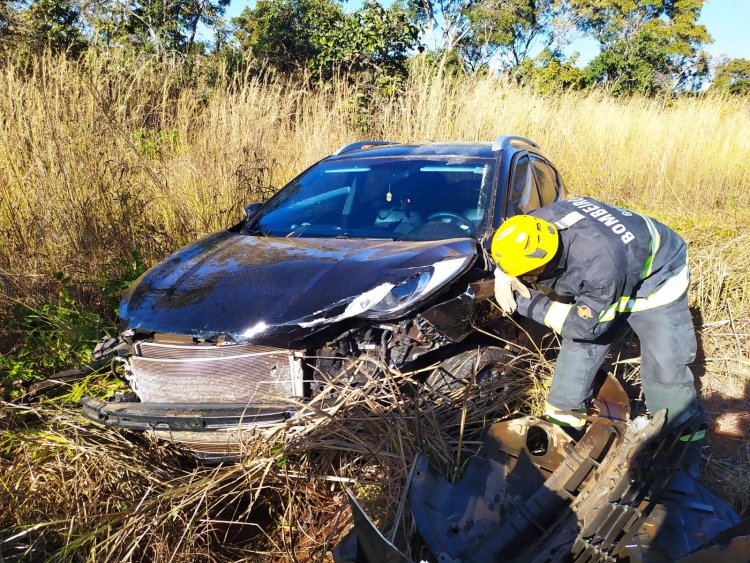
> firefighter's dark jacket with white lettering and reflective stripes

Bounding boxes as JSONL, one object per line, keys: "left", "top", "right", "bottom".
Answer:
{"left": 527, "top": 197, "right": 690, "bottom": 340}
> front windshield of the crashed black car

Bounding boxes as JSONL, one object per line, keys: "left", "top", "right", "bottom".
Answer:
{"left": 244, "top": 156, "right": 493, "bottom": 240}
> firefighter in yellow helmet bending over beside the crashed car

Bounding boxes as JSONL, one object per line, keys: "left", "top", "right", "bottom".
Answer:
{"left": 491, "top": 197, "right": 705, "bottom": 452}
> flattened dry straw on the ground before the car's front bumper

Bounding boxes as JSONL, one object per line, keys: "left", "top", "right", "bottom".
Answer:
{"left": 0, "top": 355, "right": 546, "bottom": 561}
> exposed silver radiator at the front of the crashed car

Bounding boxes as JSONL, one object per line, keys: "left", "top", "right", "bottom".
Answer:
{"left": 129, "top": 342, "right": 302, "bottom": 404}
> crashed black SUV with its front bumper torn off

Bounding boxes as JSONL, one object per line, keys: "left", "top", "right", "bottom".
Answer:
{"left": 83, "top": 136, "right": 565, "bottom": 452}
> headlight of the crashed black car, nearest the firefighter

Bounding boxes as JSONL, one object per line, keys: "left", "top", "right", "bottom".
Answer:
{"left": 362, "top": 256, "right": 472, "bottom": 317}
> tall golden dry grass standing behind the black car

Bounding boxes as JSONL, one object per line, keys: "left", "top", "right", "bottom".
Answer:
{"left": 0, "top": 57, "right": 750, "bottom": 280}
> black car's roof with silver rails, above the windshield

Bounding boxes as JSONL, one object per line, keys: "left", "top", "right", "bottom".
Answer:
{"left": 326, "top": 136, "right": 540, "bottom": 160}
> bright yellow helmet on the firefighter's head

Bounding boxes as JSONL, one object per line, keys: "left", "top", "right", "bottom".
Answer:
{"left": 492, "top": 215, "right": 560, "bottom": 276}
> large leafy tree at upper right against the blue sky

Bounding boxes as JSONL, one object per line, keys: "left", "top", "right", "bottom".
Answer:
{"left": 568, "top": 0, "right": 711, "bottom": 94}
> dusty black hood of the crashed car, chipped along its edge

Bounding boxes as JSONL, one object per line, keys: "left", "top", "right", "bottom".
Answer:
{"left": 120, "top": 231, "right": 477, "bottom": 343}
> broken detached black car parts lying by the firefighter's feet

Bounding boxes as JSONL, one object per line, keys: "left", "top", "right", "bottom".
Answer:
{"left": 334, "top": 376, "right": 750, "bottom": 563}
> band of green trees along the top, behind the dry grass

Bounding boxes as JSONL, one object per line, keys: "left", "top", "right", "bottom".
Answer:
{"left": 0, "top": 0, "right": 728, "bottom": 99}
